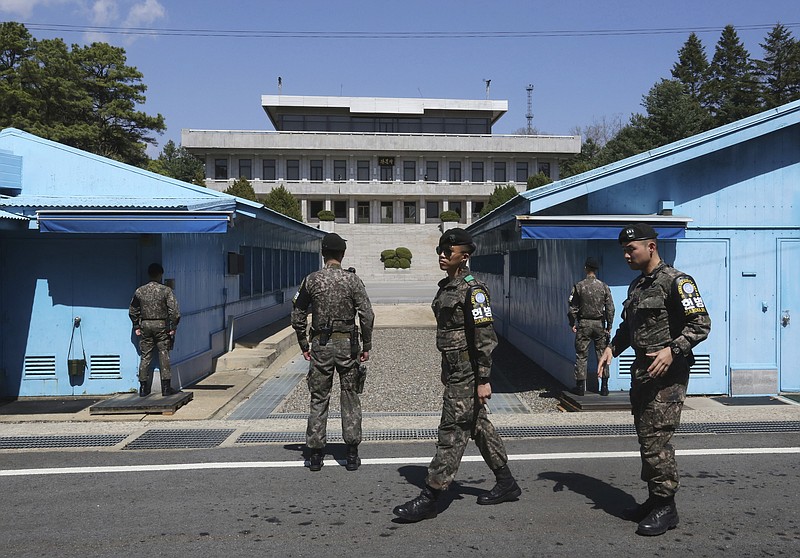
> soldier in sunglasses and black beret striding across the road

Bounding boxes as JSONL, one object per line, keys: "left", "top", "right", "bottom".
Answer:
{"left": 394, "top": 228, "right": 522, "bottom": 521}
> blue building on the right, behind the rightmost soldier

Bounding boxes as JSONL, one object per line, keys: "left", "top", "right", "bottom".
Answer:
{"left": 470, "top": 102, "right": 800, "bottom": 395}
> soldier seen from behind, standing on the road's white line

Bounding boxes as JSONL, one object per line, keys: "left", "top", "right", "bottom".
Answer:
{"left": 292, "top": 233, "right": 375, "bottom": 471}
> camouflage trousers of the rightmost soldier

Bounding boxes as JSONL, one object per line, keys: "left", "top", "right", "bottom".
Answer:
{"left": 630, "top": 370, "right": 686, "bottom": 498}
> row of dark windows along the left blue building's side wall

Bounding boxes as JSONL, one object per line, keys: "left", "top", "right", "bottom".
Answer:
{"left": 239, "top": 246, "right": 319, "bottom": 298}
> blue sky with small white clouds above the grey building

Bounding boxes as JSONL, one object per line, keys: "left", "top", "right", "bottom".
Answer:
{"left": 0, "top": 0, "right": 800, "bottom": 155}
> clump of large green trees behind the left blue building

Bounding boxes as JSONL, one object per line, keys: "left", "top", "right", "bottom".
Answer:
{"left": 0, "top": 22, "right": 165, "bottom": 167}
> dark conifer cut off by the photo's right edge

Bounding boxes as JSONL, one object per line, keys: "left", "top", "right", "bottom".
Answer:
{"left": 756, "top": 24, "right": 800, "bottom": 108}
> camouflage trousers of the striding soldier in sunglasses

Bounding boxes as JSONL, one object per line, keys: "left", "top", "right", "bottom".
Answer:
{"left": 425, "top": 351, "right": 508, "bottom": 489}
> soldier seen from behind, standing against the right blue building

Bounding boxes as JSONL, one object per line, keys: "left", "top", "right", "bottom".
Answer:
{"left": 567, "top": 257, "right": 614, "bottom": 395}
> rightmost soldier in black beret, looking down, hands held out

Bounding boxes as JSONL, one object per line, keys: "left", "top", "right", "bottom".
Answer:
{"left": 598, "top": 223, "right": 711, "bottom": 535}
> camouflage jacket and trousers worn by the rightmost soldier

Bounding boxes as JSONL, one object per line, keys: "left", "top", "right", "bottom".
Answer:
{"left": 611, "top": 262, "right": 711, "bottom": 498}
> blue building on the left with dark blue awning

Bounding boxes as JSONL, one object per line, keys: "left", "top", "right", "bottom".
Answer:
{"left": 0, "top": 129, "right": 323, "bottom": 396}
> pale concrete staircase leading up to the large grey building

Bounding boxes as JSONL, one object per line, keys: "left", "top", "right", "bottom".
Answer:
{"left": 333, "top": 223, "right": 444, "bottom": 283}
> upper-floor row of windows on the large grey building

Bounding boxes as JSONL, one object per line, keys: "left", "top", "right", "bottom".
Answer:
{"left": 214, "top": 157, "right": 550, "bottom": 182}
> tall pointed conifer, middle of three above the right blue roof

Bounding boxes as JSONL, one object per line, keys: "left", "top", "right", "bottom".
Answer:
{"left": 706, "top": 25, "right": 761, "bottom": 126}
